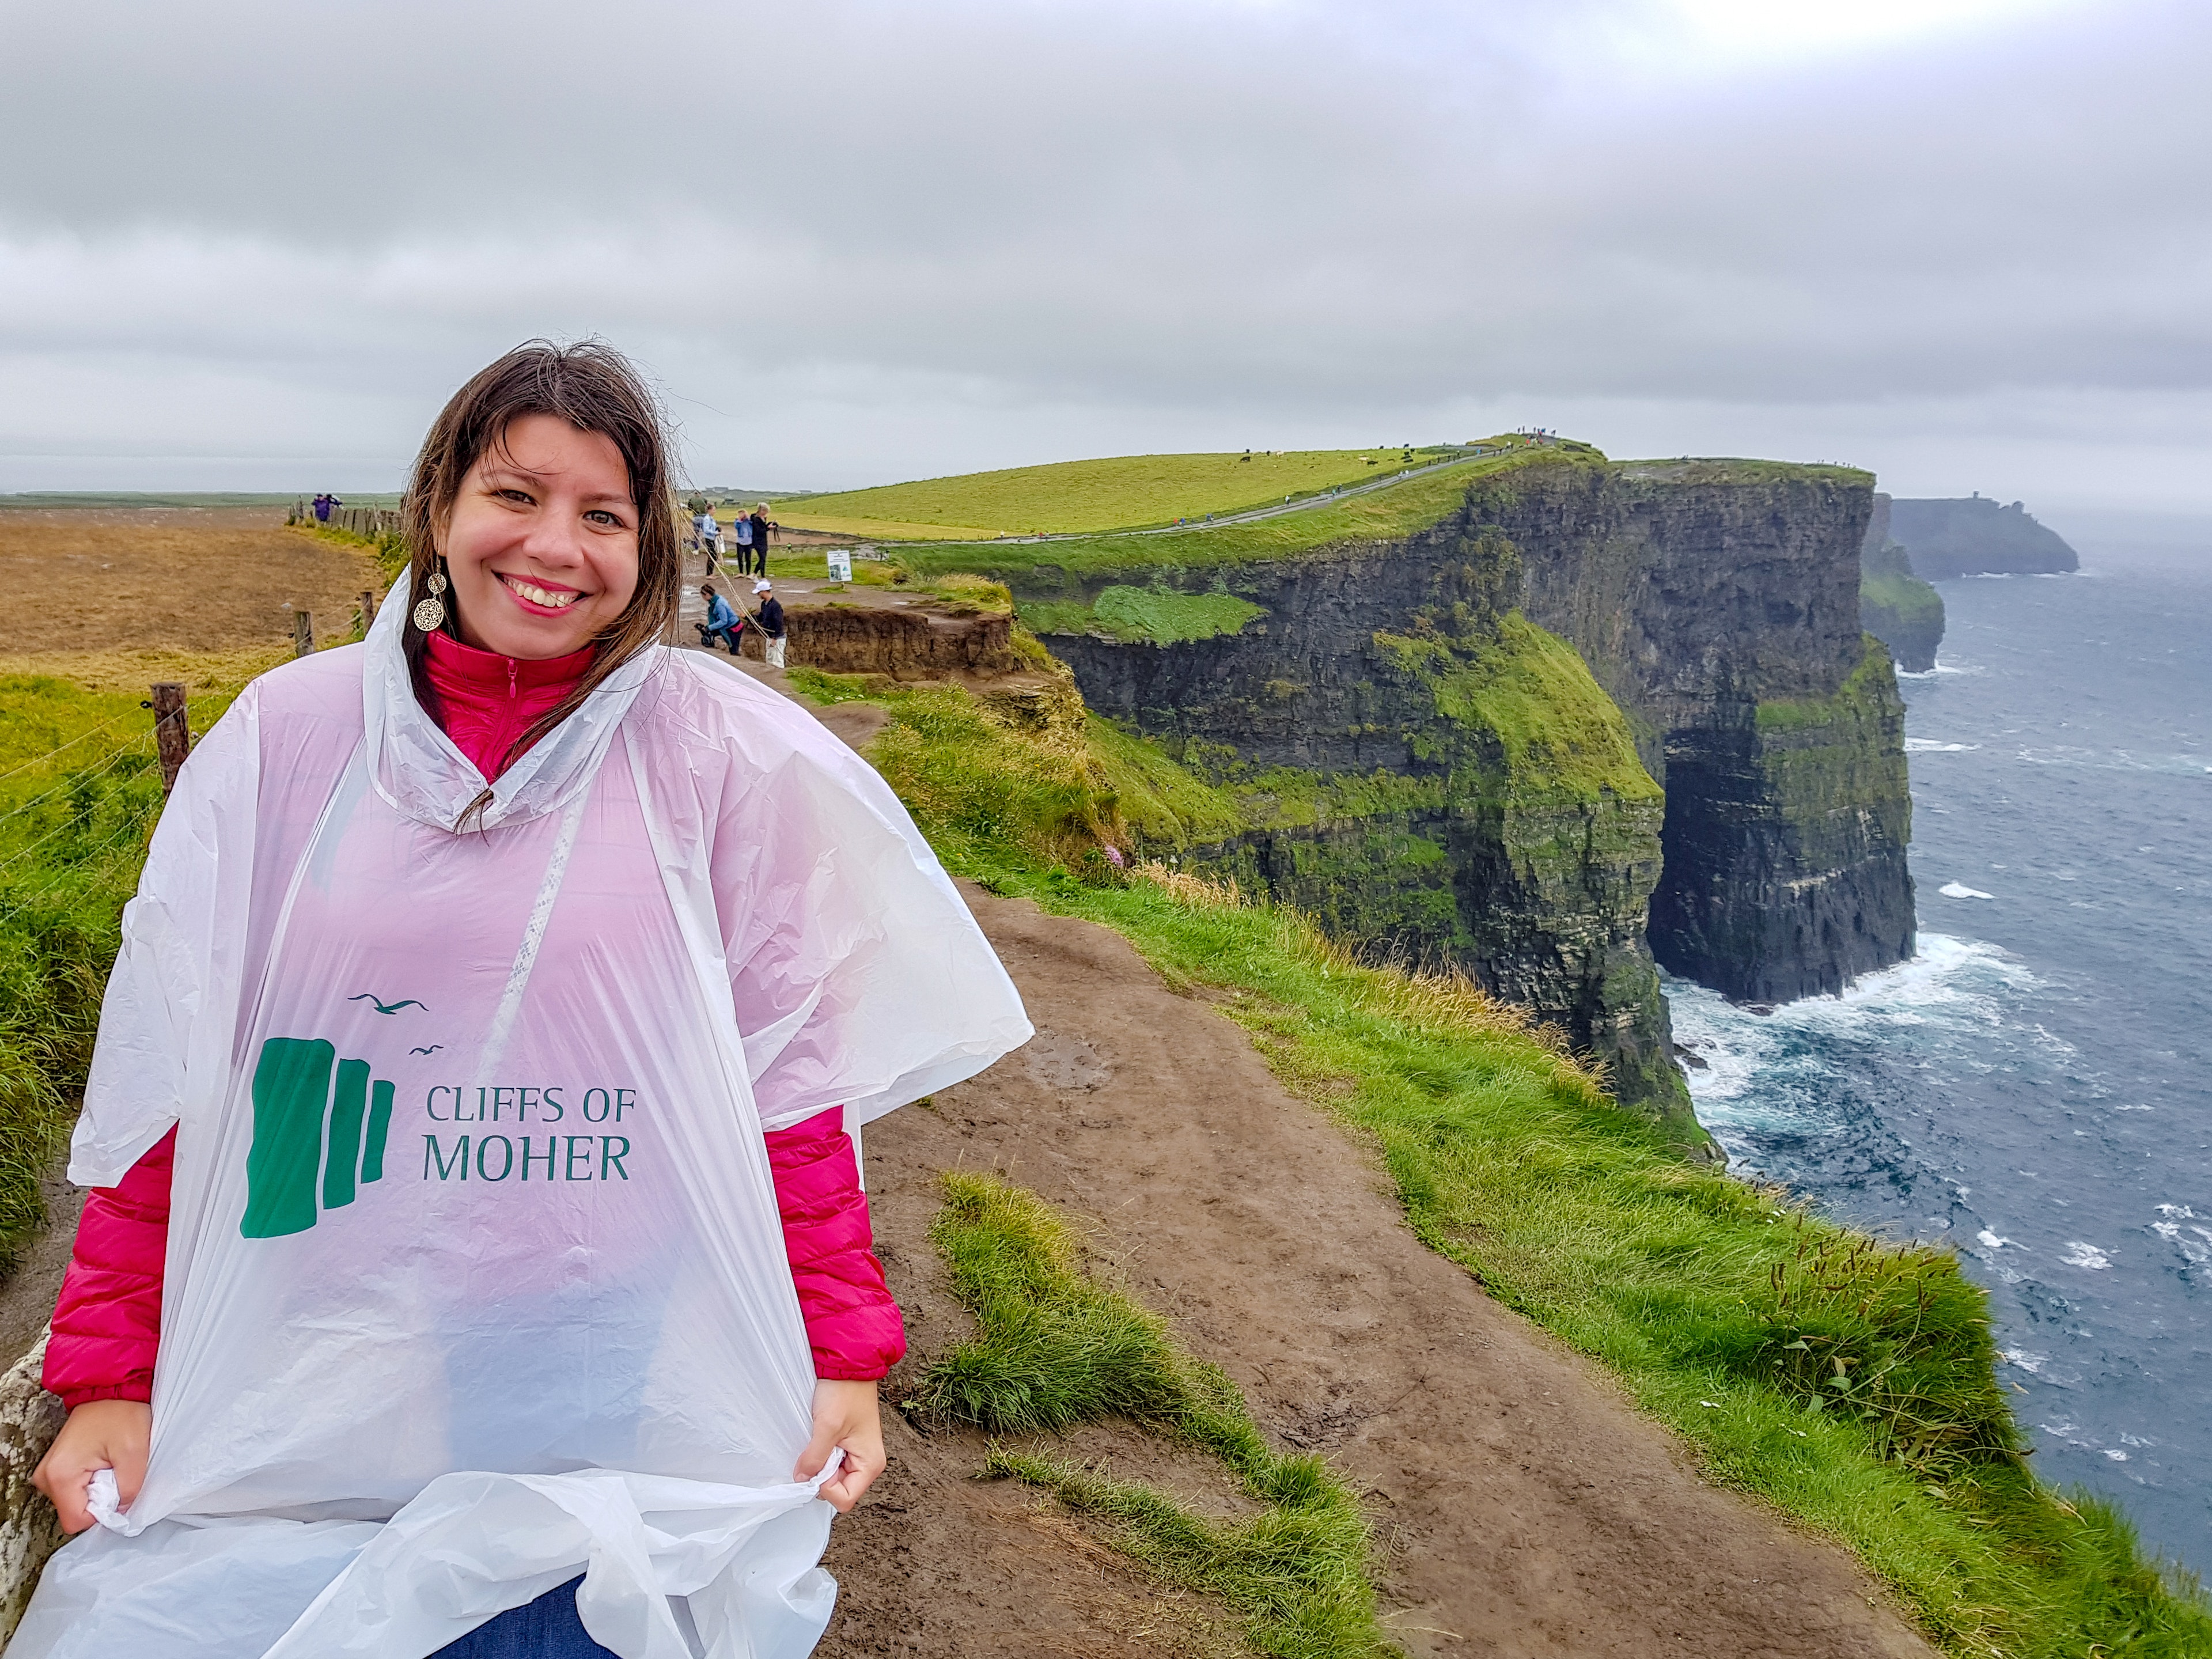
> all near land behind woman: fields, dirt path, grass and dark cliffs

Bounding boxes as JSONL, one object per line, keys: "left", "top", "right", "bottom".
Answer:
{"left": 0, "top": 434, "right": 2212, "bottom": 1659}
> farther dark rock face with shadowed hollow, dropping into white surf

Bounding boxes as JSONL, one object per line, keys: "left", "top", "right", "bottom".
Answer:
{"left": 1467, "top": 463, "right": 1914, "bottom": 1002}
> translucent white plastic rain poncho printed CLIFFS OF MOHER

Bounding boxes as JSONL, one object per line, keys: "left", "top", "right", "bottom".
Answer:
{"left": 9, "top": 588, "right": 1031, "bottom": 1659}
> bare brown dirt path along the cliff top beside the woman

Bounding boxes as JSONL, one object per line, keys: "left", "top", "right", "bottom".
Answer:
{"left": 823, "top": 889, "right": 1931, "bottom": 1659}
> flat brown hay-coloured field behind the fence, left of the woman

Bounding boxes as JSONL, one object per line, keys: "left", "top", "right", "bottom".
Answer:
{"left": 0, "top": 509, "right": 382, "bottom": 668}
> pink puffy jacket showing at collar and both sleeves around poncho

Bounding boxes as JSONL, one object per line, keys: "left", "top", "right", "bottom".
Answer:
{"left": 44, "top": 635, "right": 907, "bottom": 1409}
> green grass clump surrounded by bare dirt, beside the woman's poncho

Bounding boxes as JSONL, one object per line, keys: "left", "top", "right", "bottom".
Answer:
{"left": 911, "top": 1170, "right": 1382, "bottom": 1659}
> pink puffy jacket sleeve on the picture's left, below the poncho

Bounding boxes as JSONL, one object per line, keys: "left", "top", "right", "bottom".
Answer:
{"left": 44, "top": 1130, "right": 177, "bottom": 1411}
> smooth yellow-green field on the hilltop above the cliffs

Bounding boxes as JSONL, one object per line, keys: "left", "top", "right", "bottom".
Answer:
{"left": 777, "top": 445, "right": 1486, "bottom": 542}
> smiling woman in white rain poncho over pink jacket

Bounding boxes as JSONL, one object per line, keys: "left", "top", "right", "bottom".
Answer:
{"left": 9, "top": 343, "right": 1031, "bottom": 1659}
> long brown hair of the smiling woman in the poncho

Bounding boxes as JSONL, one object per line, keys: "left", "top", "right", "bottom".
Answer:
{"left": 400, "top": 340, "right": 684, "bottom": 791}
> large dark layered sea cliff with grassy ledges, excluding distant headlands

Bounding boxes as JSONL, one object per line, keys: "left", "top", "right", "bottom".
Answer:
{"left": 915, "top": 447, "right": 1914, "bottom": 1143}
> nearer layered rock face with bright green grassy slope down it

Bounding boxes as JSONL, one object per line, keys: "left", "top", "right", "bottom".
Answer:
{"left": 1040, "top": 513, "right": 1703, "bottom": 1146}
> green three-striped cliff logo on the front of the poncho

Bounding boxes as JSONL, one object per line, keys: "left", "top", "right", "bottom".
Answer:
{"left": 239, "top": 1037, "right": 392, "bottom": 1238}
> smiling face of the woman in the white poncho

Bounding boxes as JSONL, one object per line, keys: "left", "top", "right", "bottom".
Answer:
{"left": 440, "top": 414, "right": 637, "bottom": 657}
